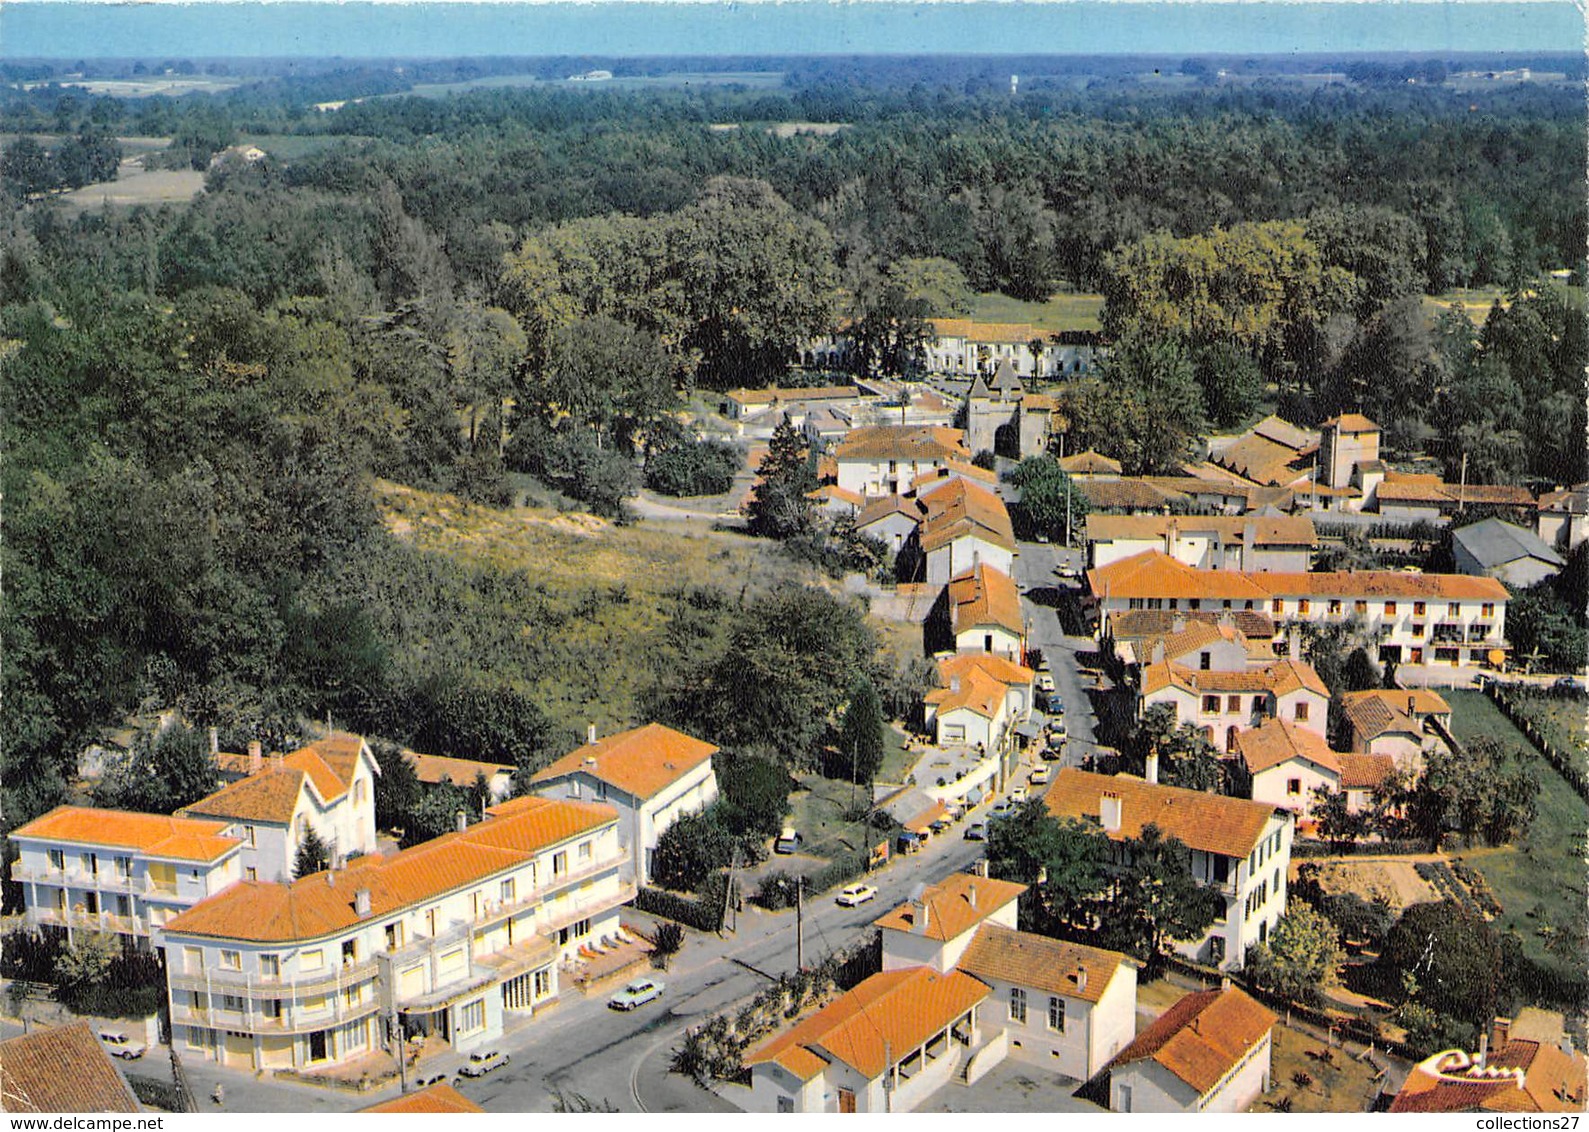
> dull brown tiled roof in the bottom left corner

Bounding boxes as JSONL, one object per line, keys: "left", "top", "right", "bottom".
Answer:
{"left": 0, "top": 1022, "right": 143, "bottom": 1113}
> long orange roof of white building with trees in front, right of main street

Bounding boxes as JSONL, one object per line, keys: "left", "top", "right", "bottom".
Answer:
{"left": 1044, "top": 766, "right": 1284, "bottom": 857}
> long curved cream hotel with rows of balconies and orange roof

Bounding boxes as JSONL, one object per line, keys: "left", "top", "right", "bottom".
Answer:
{"left": 165, "top": 798, "right": 634, "bottom": 1072}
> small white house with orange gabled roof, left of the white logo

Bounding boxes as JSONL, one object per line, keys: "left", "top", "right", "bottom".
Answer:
{"left": 1109, "top": 986, "right": 1279, "bottom": 1113}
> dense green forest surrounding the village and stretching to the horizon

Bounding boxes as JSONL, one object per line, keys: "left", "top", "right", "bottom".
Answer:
{"left": 0, "top": 75, "right": 1589, "bottom": 852}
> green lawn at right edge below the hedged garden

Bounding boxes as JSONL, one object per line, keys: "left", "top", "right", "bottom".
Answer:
{"left": 1444, "top": 688, "right": 1589, "bottom": 973}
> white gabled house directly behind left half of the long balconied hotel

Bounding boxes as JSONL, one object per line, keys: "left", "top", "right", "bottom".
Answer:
{"left": 180, "top": 733, "right": 380, "bottom": 881}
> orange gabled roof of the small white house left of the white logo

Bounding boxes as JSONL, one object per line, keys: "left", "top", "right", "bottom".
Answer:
{"left": 1109, "top": 987, "right": 1279, "bottom": 1097}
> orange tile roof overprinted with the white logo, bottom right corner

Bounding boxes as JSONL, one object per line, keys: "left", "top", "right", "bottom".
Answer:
{"left": 1390, "top": 1038, "right": 1589, "bottom": 1113}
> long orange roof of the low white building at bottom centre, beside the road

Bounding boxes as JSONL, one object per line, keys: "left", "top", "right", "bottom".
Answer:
{"left": 744, "top": 967, "right": 990, "bottom": 1081}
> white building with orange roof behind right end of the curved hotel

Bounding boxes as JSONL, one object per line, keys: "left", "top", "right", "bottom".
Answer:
{"left": 531, "top": 723, "right": 717, "bottom": 884}
